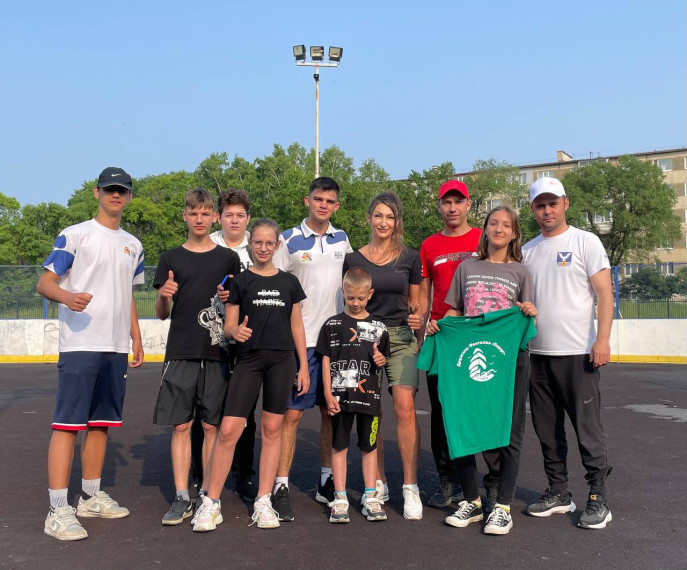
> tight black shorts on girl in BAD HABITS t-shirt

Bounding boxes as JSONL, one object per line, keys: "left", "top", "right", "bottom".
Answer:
{"left": 224, "top": 350, "right": 296, "bottom": 418}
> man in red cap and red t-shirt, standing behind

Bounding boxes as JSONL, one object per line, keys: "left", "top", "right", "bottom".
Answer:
{"left": 420, "top": 180, "right": 482, "bottom": 507}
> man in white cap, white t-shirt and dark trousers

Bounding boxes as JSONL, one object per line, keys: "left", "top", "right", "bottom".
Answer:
{"left": 522, "top": 178, "right": 613, "bottom": 529}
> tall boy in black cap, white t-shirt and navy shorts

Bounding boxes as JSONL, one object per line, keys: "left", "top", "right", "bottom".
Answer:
{"left": 36, "top": 167, "right": 143, "bottom": 540}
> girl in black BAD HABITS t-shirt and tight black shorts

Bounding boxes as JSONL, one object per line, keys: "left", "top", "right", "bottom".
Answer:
{"left": 193, "top": 219, "right": 310, "bottom": 532}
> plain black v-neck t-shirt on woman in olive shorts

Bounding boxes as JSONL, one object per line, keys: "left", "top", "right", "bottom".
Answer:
{"left": 343, "top": 247, "right": 422, "bottom": 327}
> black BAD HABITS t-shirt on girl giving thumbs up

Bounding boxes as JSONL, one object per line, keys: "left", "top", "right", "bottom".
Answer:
{"left": 229, "top": 269, "right": 305, "bottom": 352}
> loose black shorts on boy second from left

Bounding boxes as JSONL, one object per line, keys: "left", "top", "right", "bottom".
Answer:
{"left": 153, "top": 359, "right": 228, "bottom": 426}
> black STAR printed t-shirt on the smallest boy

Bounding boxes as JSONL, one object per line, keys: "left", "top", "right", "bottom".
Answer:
{"left": 315, "top": 313, "right": 389, "bottom": 416}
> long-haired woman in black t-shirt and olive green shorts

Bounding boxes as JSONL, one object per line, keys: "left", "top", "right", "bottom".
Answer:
{"left": 343, "top": 192, "right": 422, "bottom": 520}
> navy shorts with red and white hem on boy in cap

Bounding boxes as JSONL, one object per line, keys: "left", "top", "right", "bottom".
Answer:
{"left": 52, "top": 352, "right": 128, "bottom": 431}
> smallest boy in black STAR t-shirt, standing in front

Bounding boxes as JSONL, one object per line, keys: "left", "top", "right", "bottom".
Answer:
{"left": 317, "top": 267, "right": 389, "bottom": 523}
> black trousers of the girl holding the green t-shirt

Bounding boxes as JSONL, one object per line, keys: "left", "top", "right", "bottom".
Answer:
{"left": 455, "top": 351, "right": 530, "bottom": 505}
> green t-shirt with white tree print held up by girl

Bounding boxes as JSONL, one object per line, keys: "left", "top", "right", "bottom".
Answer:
{"left": 417, "top": 307, "right": 537, "bottom": 459}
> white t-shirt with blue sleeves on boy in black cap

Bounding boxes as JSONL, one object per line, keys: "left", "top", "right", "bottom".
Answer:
{"left": 43, "top": 220, "right": 144, "bottom": 354}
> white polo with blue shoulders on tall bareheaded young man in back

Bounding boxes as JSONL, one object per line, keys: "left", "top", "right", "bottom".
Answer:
{"left": 273, "top": 218, "right": 353, "bottom": 348}
